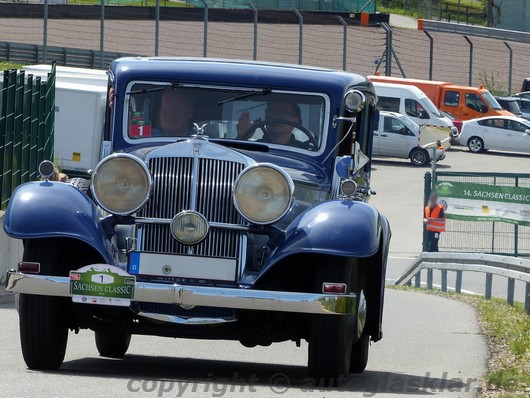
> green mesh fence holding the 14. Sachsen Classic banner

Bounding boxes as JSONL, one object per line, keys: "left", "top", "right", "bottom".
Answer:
{"left": 423, "top": 172, "right": 530, "bottom": 257}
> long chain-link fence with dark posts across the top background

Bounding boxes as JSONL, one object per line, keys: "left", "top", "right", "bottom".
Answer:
{"left": 0, "top": 0, "right": 530, "bottom": 94}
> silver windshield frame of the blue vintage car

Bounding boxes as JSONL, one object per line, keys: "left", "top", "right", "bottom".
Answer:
{"left": 121, "top": 80, "right": 331, "bottom": 156}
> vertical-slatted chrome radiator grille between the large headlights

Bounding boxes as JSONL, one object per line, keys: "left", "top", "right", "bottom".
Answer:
{"left": 138, "top": 158, "right": 245, "bottom": 258}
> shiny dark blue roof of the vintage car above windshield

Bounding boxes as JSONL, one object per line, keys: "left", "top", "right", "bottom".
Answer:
{"left": 110, "top": 57, "right": 374, "bottom": 95}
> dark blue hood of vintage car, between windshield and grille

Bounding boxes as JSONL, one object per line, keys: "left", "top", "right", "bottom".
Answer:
{"left": 127, "top": 139, "right": 331, "bottom": 189}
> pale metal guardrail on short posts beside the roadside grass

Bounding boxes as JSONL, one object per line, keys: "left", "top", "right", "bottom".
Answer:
{"left": 394, "top": 253, "right": 530, "bottom": 315}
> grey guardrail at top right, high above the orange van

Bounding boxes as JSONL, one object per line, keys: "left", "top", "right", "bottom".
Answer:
{"left": 418, "top": 19, "right": 530, "bottom": 43}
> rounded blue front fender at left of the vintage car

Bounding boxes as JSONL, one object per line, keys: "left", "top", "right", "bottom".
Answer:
{"left": 4, "top": 181, "right": 113, "bottom": 264}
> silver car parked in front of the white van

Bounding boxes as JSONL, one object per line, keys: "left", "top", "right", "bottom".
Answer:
{"left": 373, "top": 112, "right": 445, "bottom": 166}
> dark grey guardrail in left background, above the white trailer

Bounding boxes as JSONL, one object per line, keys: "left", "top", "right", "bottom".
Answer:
{"left": 0, "top": 41, "right": 136, "bottom": 69}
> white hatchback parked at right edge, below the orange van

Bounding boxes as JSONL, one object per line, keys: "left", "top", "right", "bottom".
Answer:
{"left": 459, "top": 116, "right": 530, "bottom": 153}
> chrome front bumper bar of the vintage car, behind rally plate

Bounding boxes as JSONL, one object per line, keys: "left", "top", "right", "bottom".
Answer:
{"left": 6, "top": 271, "right": 356, "bottom": 315}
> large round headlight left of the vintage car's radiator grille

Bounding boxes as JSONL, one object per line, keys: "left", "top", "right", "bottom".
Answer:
{"left": 92, "top": 154, "right": 152, "bottom": 215}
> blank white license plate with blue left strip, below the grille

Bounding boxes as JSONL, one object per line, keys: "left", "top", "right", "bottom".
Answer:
{"left": 129, "top": 252, "right": 237, "bottom": 282}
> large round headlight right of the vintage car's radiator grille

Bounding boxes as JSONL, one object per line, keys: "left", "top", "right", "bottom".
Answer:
{"left": 233, "top": 163, "right": 294, "bottom": 224}
